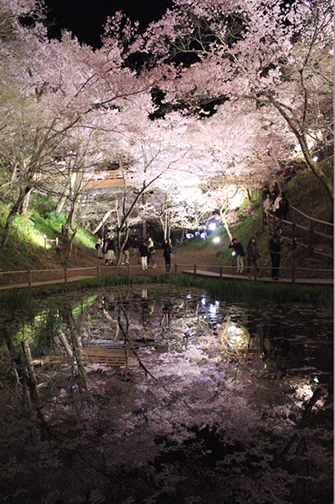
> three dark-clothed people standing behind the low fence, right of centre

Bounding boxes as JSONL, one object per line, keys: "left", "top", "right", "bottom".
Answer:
{"left": 229, "top": 226, "right": 283, "bottom": 280}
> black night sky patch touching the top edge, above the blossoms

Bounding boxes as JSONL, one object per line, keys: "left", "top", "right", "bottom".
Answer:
{"left": 46, "top": 0, "right": 172, "bottom": 47}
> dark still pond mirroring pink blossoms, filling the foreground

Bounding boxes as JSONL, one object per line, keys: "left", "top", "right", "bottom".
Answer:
{"left": 0, "top": 285, "right": 333, "bottom": 504}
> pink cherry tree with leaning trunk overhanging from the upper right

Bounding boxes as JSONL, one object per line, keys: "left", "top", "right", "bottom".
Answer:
{"left": 136, "top": 0, "right": 333, "bottom": 203}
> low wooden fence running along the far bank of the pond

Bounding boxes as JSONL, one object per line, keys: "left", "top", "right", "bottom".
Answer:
{"left": 0, "top": 263, "right": 333, "bottom": 290}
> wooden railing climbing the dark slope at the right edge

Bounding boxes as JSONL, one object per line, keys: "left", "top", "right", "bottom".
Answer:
{"left": 262, "top": 205, "right": 334, "bottom": 259}
